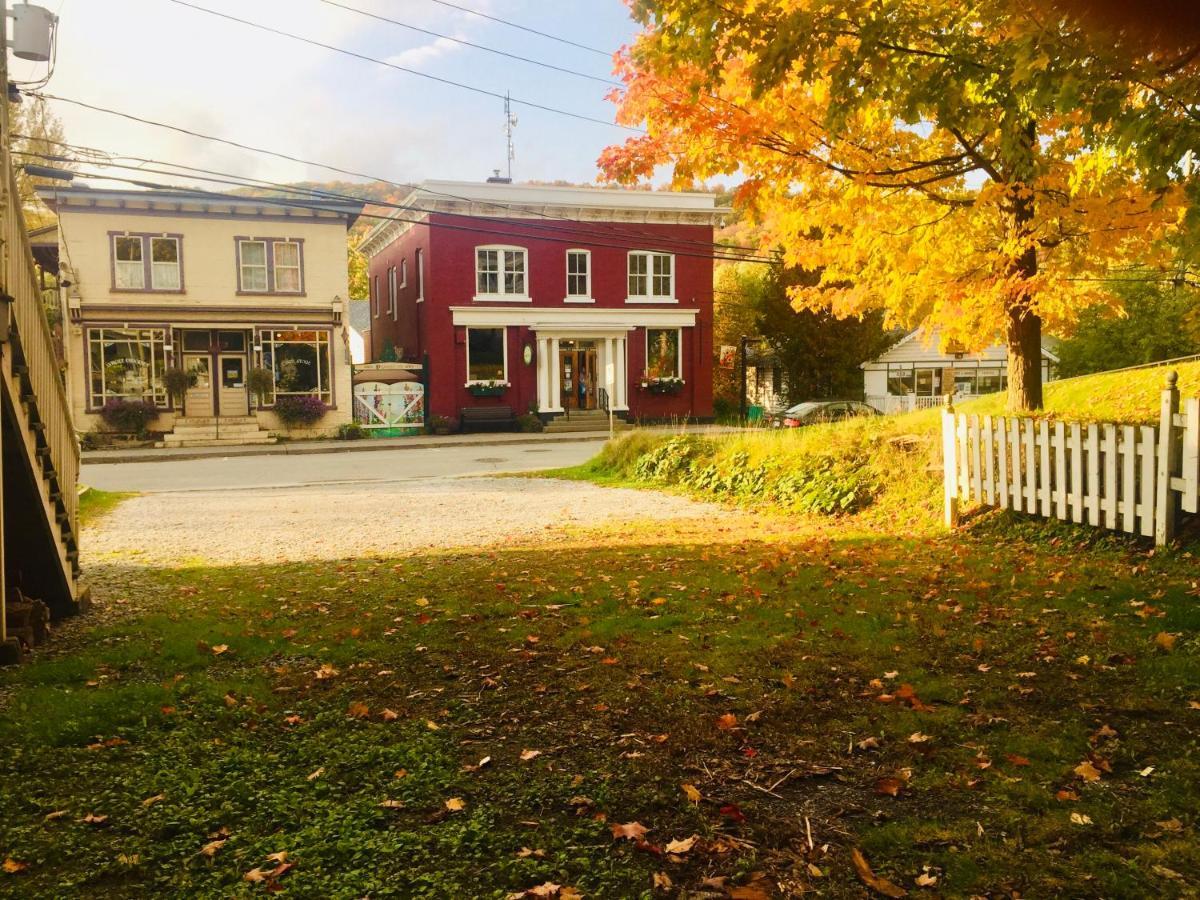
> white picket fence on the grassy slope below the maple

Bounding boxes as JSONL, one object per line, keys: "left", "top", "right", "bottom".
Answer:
{"left": 942, "top": 372, "right": 1200, "bottom": 545}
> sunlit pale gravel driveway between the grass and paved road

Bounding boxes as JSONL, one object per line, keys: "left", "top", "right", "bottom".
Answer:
{"left": 83, "top": 478, "right": 727, "bottom": 565}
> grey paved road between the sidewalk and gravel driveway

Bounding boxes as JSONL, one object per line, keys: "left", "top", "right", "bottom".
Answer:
{"left": 80, "top": 440, "right": 601, "bottom": 493}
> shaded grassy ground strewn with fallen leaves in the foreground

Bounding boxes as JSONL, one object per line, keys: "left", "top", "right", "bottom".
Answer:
{"left": 0, "top": 518, "right": 1200, "bottom": 898}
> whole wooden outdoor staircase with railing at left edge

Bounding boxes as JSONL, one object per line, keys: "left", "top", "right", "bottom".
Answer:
{"left": 0, "top": 168, "right": 86, "bottom": 662}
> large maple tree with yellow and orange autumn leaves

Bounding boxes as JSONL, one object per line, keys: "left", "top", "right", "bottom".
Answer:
{"left": 600, "top": 0, "right": 1200, "bottom": 409}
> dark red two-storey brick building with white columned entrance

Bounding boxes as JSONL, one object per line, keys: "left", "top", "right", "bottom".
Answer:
{"left": 362, "top": 181, "right": 722, "bottom": 421}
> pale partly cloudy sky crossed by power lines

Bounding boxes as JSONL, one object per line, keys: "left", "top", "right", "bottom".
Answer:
{"left": 11, "top": 0, "right": 636, "bottom": 190}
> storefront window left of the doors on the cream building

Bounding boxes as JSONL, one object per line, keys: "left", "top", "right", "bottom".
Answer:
{"left": 88, "top": 328, "right": 167, "bottom": 407}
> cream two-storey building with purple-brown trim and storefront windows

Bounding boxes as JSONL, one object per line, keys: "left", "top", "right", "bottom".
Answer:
{"left": 41, "top": 187, "right": 361, "bottom": 444}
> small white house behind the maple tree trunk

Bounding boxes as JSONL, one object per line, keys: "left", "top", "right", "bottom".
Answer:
{"left": 862, "top": 330, "right": 1058, "bottom": 413}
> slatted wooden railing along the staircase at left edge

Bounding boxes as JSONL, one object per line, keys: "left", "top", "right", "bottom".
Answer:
{"left": 0, "top": 163, "right": 79, "bottom": 562}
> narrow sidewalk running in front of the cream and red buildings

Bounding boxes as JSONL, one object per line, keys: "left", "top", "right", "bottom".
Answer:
{"left": 80, "top": 425, "right": 738, "bottom": 466}
